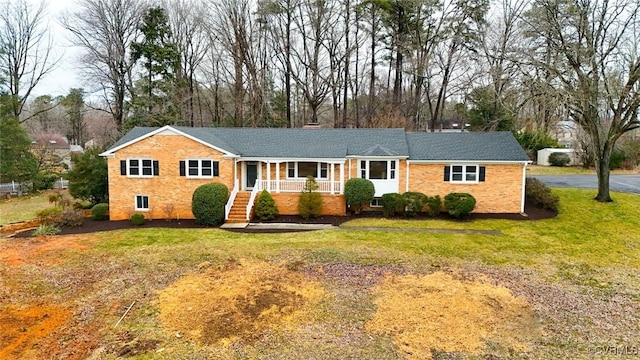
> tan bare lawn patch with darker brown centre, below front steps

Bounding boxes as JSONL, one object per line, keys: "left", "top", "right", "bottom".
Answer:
{"left": 159, "top": 263, "right": 324, "bottom": 344}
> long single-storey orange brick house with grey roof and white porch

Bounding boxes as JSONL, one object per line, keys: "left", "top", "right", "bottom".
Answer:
{"left": 102, "top": 126, "right": 531, "bottom": 221}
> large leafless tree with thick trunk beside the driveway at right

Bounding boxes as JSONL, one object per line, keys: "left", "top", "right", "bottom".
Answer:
{"left": 526, "top": 0, "right": 640, "bottom": 202}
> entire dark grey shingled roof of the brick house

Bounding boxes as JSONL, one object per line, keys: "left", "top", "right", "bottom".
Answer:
{"left": 106, "top": 127, "right": 529, "bottom": 161}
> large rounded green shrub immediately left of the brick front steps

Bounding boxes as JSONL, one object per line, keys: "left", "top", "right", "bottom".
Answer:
{"left": 191, "top": 183, "right": 229, "bottom": 226}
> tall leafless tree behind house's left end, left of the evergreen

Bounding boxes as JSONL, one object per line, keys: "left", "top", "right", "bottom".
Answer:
{"left": 61, "top": 0, "right": 145, "bottom": 130}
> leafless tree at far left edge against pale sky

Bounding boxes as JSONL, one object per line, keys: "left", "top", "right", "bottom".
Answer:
{"left": 0, "top": 0, "right": 58, "bottom": 117}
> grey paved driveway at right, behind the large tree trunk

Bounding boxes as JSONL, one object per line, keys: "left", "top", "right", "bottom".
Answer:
{"left": 533, "top": 175, "right": 640, "bottom": 194}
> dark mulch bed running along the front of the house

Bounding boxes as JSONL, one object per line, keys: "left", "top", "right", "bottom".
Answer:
{"left": 14, "top": 206, "right": 557, "bottom": 238}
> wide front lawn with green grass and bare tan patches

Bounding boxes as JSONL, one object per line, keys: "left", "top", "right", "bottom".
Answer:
{"left": 0, "top": 189, "right": 640, "bottom": 359}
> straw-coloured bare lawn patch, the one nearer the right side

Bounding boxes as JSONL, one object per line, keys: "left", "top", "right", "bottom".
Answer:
{"left": 365, "top": 272, "right": 540, "bottom": 359}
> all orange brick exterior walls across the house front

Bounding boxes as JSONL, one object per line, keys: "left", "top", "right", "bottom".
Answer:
{"left": 108, "top": 134, "right": 523, "bottom": 220}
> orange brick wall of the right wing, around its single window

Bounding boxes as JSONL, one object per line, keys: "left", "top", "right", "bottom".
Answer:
{"left": 409, "top": 163, "right": 523, "bottom": 213}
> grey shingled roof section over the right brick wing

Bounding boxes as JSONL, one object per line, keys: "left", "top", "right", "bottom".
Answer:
{"left": 407, "top": 132, "right": 530, "bottom": 161}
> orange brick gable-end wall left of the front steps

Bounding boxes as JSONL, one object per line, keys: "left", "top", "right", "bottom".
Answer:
{"left": 108, "top": 134, "right": 234, "bottom": 220}
